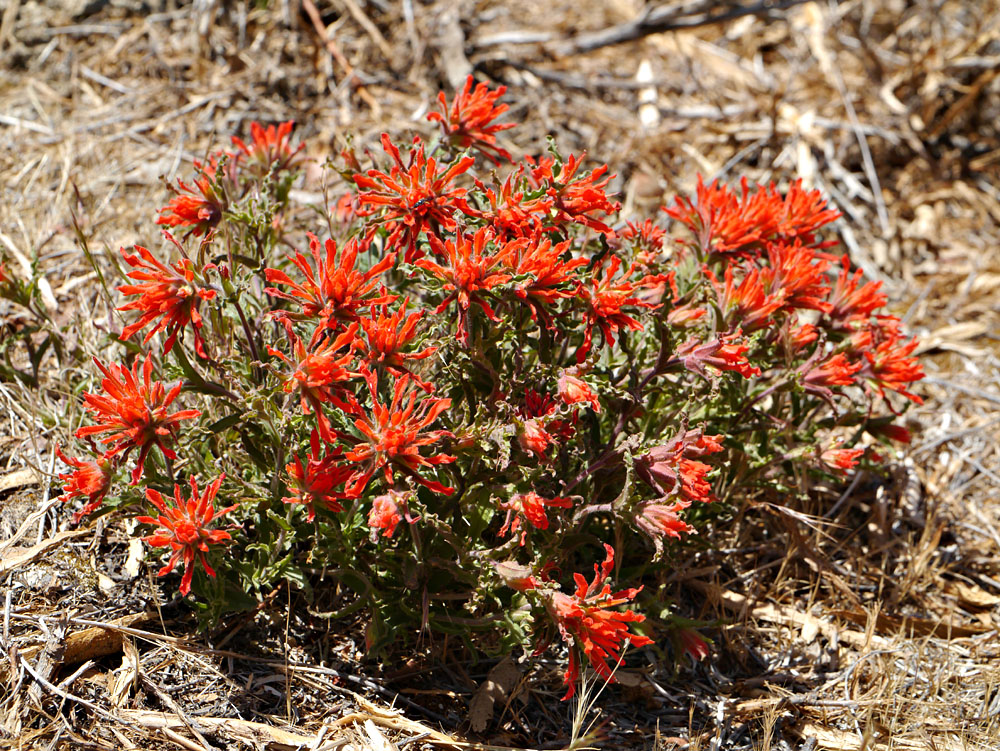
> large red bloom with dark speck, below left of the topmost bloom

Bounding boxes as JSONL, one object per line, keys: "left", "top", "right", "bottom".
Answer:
{"left": 354, "top": 133, "right": 476, "bottom": 263}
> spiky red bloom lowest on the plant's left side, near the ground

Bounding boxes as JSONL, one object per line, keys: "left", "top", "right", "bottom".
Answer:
{"left": 136, "top": 475, "right": 236, "bottom": 595}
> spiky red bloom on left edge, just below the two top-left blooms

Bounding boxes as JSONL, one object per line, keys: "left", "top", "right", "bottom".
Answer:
{"left": 118, "top": 239, "right": 215, "bottom": 359}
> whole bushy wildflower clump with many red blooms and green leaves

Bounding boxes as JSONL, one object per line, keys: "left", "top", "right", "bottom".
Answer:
{"left": 59, "top": 79, "right": 922, "bottom": 696}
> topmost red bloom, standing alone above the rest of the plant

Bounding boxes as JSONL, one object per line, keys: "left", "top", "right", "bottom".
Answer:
{"left": 427, "top": 76, "right": 515, "bottom": 165}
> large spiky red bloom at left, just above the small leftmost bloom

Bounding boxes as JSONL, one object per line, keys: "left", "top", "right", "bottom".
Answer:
{"left": 76, "top": 354, "right": 201, "bottom": 485}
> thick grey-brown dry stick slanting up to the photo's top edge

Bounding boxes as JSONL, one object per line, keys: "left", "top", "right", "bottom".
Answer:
{"left": 547, "top": 0, "right": 806, "bottom": 56}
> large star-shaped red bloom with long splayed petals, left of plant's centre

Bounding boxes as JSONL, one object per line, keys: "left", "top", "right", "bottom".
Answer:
{"left": 345, "top": 374, "right": 455, "bottom": 496}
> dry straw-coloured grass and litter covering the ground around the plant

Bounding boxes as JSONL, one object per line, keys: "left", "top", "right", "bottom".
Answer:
{"left": 0, "top": 0, "right": 1000, "bottom": 751}
